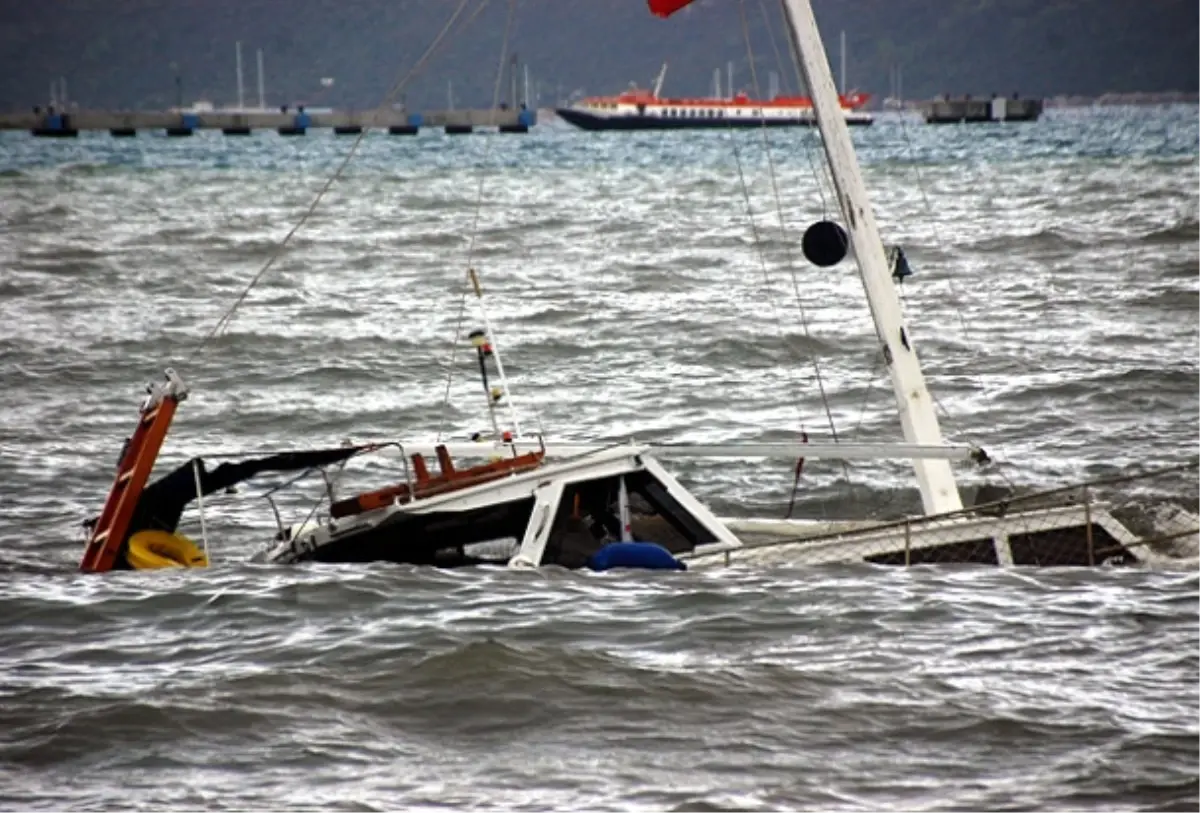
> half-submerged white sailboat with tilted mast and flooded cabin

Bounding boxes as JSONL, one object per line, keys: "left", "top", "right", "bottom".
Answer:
{"left": 82, "top": 0, "right": 1200, "bottom": 572}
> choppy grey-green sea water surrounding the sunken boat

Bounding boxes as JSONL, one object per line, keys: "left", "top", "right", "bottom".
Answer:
{"left": 0, "top": 108, "right": 1200, "bottom": 811}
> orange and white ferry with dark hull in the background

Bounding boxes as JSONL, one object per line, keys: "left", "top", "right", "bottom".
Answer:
{"left": 556, "top": 82, "right": 874, "bottom": 130}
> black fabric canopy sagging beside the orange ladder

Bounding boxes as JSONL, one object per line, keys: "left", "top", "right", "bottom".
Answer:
{"left": 128, "top": 445, "right": 376, "bottom": 536}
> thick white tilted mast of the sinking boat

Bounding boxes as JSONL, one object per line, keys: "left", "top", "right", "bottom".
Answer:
{"left": 784, "top": 0, "right": 962, "bottom": 513}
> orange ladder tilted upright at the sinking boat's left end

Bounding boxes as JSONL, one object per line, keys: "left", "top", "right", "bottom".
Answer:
{"left": 79, "top": 368, "right": 187, "bottom": 573}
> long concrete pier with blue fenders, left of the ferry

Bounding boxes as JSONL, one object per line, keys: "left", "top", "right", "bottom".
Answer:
{"left": 0, "top": 109, "right": 538, "bottom": 138}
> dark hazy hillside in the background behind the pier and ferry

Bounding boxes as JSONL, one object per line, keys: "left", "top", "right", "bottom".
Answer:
{"left": 0, "top": 0, "right": 1200, "bottom": 108}
